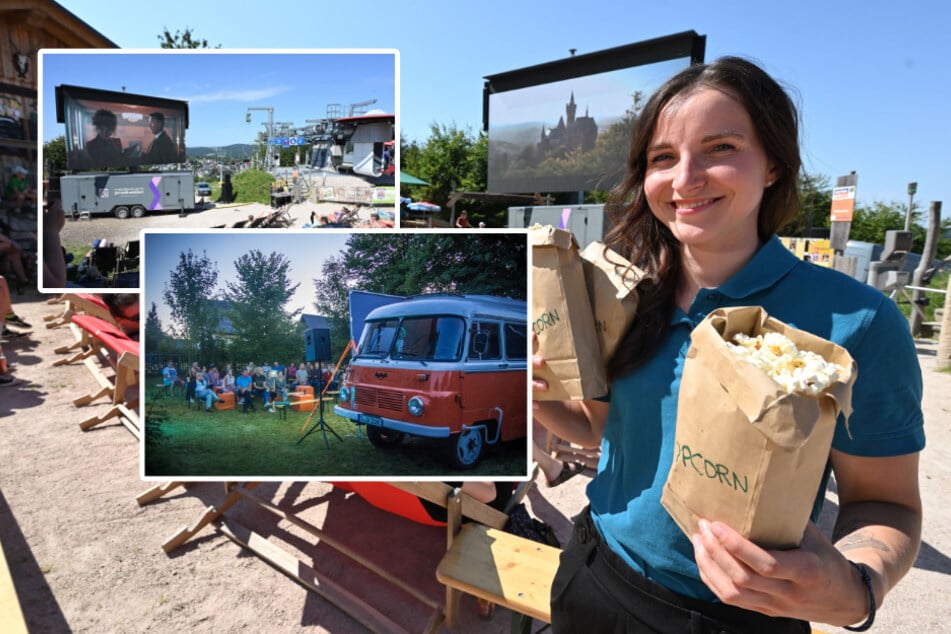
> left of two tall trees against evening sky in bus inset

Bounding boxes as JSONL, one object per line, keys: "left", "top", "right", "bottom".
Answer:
{"left": 162, "top": 249, "right": 218, "bottom": 359}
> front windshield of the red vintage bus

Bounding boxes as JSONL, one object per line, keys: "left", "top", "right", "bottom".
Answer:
{"left": 358, "top": 315, "right": 466, "bottom": 361}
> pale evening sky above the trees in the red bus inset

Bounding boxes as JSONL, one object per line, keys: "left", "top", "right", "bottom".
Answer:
{"left": 142, "top": 229, "right": 351, "bottom": 328}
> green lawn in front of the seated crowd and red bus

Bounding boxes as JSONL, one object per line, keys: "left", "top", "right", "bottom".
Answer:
{"left": 144, "top": 379, "right": 527, "bottom": 480}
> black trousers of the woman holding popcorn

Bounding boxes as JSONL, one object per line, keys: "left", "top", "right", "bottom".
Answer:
{"left": 551, "top": 508, "right": 811, "bottom": 634}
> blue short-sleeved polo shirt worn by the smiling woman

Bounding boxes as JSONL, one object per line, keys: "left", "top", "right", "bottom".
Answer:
{"left": 588, "top": 237, "right": 925, "bottom": 601}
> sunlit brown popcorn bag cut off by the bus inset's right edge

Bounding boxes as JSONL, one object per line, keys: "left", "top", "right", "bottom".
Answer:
{"left": 529, "top": 225, "right": 608, "bottom": 401}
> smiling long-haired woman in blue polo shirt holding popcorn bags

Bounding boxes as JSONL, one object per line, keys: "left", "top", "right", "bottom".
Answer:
{"left": 533, "top": 57, "right": 924, "bottom": 634}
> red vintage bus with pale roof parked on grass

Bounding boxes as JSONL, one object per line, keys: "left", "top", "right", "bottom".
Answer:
{"left": 334, "top": 293, "right": 528, "bottom": 469}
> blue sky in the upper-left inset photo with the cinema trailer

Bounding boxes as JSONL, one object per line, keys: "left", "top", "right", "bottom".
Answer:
{"left": 42, "top": 49, "right": 397, "bottom": 147}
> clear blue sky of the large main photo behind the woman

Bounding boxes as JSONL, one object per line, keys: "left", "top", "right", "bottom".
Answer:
{"left": 54, "top": 0, "right": 951, "bottom": 210}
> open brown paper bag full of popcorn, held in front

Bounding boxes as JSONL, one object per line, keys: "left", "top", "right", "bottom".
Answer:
{"left": 661, "top": 306, "right": 857, "bottom": 548}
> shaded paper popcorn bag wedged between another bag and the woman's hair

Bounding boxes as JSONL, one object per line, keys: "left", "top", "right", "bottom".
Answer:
{"left": 581, "top": 242, "right": 644, "bottom": 366}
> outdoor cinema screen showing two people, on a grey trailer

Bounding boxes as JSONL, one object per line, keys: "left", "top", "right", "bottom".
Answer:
{"left": 56, "top": 85, "right": 188, "bottom": 171}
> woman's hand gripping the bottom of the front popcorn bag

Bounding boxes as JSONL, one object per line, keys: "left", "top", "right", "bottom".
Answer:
{"left": 692, "top": 520, "right": 869, "bottom": 625}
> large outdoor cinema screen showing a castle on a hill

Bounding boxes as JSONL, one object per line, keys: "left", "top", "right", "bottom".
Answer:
{"left": 483, "top": 31, "right": 706, "bottom": 194}
